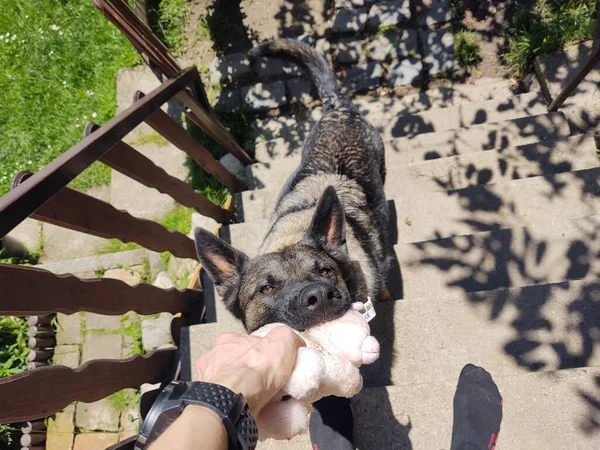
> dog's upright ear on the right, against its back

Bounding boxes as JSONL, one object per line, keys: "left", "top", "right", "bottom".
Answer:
{"left": 306, "top": 186, "right": 347, "bottom": 258}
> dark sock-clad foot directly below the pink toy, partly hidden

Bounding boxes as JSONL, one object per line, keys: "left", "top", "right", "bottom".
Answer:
{"left": 308, "top": 396, "right": 354, "bottom": 450}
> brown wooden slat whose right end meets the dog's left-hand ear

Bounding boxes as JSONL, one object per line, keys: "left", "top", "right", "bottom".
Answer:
{"left": 31, "top": 184, "right": 198, "bottom": 259}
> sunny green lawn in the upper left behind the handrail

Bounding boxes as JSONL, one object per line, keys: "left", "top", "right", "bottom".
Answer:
{"left": 0, "top": 0, "right": 140, "bottom": 195}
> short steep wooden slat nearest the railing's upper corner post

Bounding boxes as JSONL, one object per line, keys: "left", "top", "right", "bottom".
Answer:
{"left": 135, "top": 91, "right": 247, "bottom": 192}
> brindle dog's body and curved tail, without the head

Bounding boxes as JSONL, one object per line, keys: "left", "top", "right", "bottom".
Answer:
{"left": 251, "top": 39, "right": 389, "bottom": 296}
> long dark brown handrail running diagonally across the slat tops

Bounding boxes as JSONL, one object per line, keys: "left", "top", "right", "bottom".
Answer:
{"left": 0, "top": 68, "right": 198, "bottom": 237}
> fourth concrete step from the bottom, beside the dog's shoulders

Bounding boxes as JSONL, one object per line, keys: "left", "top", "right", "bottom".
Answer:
{"left": 227, "top": 168, "right": 600, "bottom": 256}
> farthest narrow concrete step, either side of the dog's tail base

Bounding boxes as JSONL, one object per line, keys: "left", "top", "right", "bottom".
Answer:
{"left": 248, "top": 79, "right": 514, "bottom": 145}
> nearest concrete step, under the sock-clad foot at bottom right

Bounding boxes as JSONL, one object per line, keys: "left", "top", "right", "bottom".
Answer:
{"left": 354, "top": 370, "right": 600, "bottom": 450}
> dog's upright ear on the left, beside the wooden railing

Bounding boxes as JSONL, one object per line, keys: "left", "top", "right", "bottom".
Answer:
{"left": 194, "top": 228, "right": 248, "bottom": 298}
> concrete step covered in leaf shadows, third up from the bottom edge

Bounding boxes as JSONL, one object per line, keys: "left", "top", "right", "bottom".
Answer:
{"left": 388, "top": 215, "right": 600, "bottom": 298}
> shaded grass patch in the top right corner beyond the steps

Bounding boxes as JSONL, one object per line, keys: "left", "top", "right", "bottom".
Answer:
{"left": 503, "top": 0, "right": 596, "bottom": 77}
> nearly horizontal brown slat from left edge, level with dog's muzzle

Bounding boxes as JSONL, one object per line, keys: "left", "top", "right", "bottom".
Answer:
{"left": 0, "top": 264, "right": 203, "bottom": 316}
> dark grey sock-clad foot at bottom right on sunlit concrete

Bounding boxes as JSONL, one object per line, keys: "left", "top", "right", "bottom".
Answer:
{"left": 450, "top": 364, "right": 502, "bottom": 450}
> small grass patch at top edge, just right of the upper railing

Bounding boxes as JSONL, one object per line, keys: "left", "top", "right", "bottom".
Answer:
{"left": 148, "top": 0, "right": 188, "bottom": 52}
